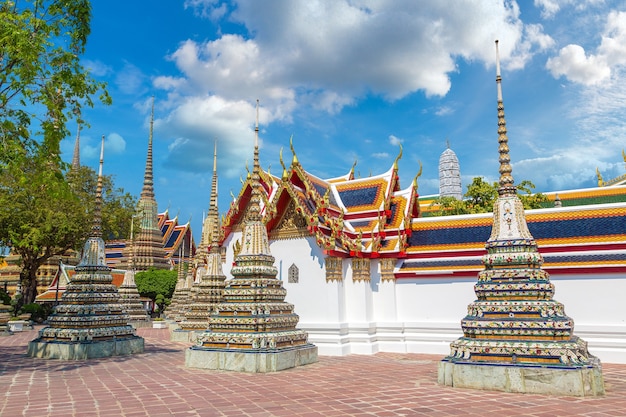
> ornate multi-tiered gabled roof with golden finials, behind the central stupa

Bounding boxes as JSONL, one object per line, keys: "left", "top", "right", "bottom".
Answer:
{"left": 224, "top": 140, "right": 419, "bottom": 257}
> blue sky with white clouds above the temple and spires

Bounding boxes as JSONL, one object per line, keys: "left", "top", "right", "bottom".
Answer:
{"left": 62, "top": 0, "right": 626, "bottom": 238}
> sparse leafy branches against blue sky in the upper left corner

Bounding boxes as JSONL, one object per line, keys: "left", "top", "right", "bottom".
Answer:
{"left": 0, "top": 0, "right": 111, "bottom": 158}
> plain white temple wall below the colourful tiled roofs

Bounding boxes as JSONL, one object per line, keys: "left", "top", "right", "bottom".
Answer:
{"left": 224, "top": 233, "right": 626, "bottom": 363}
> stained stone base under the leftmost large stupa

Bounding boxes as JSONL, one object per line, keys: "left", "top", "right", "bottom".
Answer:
{"left": 27, "top": 336, "right": 144, "bottom": 360}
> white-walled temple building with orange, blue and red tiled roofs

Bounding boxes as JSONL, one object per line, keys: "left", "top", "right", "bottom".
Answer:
{"left": 212, "top": 106, "right": 626, "bottom": 363}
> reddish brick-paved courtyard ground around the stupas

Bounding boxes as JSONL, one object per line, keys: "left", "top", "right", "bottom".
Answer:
{"left": 0, "top": 328, "right": 626, "bottom": 417}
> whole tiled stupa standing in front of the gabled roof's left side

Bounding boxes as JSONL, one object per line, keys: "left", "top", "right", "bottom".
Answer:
{"left": 185, "top": 104, "right": 317, "bottom": 372}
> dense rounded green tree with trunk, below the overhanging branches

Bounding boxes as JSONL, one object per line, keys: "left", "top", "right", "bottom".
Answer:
{"left": 0, "top": 151, "right": 91, "bottom": 307}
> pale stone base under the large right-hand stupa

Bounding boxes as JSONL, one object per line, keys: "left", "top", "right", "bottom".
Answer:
{"left": 438, "top": 360, "right": 605, "bottom": 397}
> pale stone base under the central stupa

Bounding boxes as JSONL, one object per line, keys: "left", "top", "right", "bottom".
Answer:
{"left": 185, "top": 344, "right": 317, "bottom": 373}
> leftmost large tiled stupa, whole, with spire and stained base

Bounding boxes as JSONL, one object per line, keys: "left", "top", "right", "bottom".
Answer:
{"left": 28, "top": 136, "right": 144, "bottom": 360}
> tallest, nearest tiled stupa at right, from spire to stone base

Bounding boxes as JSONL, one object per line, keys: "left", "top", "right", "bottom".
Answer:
{"left": 439, "top": 41, "right": 604, "bottom": 396}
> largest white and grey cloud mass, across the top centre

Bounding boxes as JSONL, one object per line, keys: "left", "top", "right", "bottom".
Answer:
{"left": 154, "top": 0, "right": 552, "bottom": 179}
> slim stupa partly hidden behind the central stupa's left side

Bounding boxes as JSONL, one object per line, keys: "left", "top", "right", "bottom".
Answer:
{"left": 171, "top": 144, "right": 226, "bottom": 342}
